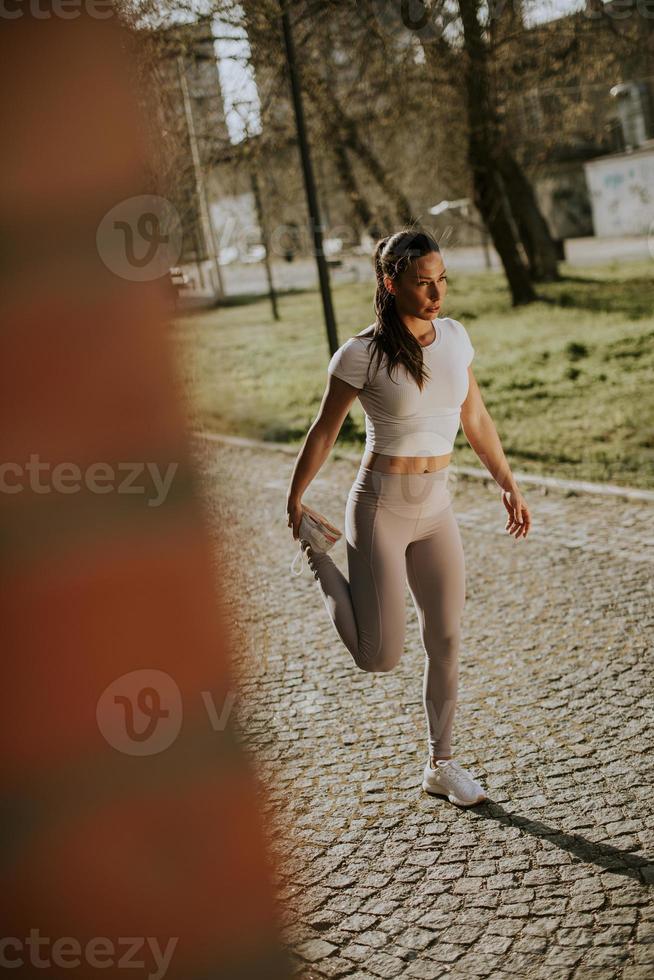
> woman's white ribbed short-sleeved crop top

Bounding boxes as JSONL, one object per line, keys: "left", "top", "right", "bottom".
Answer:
{"left": 327, "top": 316, "right": 474, "bottom": 456}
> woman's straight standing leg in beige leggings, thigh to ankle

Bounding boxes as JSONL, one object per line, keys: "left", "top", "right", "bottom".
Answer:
{"left": 406, "top": 498, "right": 465, "bottom": 759}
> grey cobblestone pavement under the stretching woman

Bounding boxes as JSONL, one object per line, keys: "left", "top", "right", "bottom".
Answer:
{"left": 194, "top": 440, "right": 654, "bottom": 980}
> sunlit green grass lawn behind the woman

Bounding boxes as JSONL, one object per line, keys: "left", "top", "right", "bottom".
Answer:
{"left": 174, "top": 262, "right": 654, "bottom": 488}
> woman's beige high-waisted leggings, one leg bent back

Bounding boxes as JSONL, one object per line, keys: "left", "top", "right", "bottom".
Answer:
{"left": 308, "top": 464, "right": 465, "bottom": 756}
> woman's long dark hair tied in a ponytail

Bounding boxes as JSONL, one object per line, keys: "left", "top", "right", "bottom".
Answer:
{"left": 371, "top": 228, "right": 440, "bottom": 391}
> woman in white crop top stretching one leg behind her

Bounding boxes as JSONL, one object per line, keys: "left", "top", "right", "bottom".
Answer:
{"left": 286, "top": 229, "right": 531, "bottom": 806}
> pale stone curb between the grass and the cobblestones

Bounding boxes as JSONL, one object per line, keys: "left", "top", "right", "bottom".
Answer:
{"left": 190, "top": 430, "right": 654, "bottom": 503}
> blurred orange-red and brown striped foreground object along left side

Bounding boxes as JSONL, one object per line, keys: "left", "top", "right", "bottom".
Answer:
{"left": 0, "top": 4, "right": 291, "bottom": 980}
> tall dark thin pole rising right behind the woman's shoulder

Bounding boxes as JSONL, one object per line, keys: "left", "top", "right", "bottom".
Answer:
{"left": 279, "top": 0, "right": 338, "bottom": 354}
